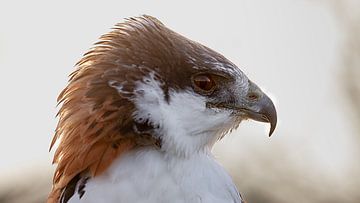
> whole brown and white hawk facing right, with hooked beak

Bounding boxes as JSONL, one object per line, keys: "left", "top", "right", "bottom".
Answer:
{"left": 47, "top": 15, "right": 277, "bottom": 203}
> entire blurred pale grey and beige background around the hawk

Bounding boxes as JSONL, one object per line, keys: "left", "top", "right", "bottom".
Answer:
{"left": 0, "top": 0, "right": 360, "bottom": 203}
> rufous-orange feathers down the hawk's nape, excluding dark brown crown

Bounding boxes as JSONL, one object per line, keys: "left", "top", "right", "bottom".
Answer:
{"left": 47, "top": 16, "right": 169, "bottom": 203}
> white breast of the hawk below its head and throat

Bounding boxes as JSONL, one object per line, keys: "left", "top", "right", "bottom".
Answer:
{"left": 69, "top": 148, "right": 241, "bottom": 203}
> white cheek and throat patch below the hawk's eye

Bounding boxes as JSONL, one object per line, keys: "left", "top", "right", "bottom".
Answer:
{"left": 134, "top": 75, "right": 235, "bottom": 156}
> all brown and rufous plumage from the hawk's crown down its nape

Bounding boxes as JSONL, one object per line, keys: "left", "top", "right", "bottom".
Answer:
{"left": 48, "top": 13, "right": 225, "bottom": 203}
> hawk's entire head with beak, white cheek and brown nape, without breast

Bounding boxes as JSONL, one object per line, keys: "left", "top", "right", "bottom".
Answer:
{"left": 54, "top": 16, "right": 277, "bottom": 170}
